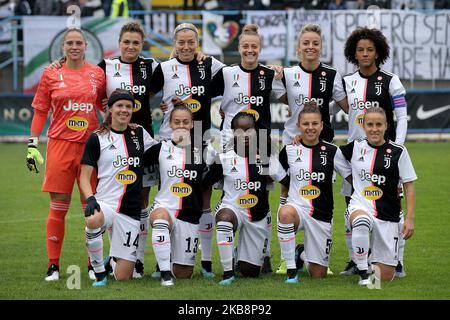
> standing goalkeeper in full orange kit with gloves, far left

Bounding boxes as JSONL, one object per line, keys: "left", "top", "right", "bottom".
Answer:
{"left": 27, "top": 29, "right": 105, "bottom": 281}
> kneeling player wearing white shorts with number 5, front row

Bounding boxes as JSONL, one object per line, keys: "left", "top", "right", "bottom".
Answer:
{"left": 278, "top": 103, "right": 351, "bottom": 284}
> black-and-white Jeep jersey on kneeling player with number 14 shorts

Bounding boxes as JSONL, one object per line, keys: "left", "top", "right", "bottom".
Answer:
{"left": 81, "top": 126, "right": 156, "bottom": 220}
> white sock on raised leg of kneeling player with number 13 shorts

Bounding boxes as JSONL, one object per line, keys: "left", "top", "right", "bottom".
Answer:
{"left": 152, "top": 219, "right": 171, "bottom": 271}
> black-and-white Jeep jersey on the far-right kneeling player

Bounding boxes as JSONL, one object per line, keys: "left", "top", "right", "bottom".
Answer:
{"left": 340, "top": 139, "right": 417, "bottom": 222}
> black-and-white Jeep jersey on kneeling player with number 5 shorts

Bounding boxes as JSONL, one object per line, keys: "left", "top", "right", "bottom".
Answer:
{"left": 280, "top": 140, "right": 351, "bottom": 222}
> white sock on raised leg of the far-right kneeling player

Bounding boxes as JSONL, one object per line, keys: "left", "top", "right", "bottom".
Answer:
{"left": 352, "top": 216, "right": 370, "bottom": 270}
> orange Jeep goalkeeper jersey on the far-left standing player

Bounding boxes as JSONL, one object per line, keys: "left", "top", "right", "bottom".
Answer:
{"left": 32, "top": 63, "right": 105, "bottom": 143}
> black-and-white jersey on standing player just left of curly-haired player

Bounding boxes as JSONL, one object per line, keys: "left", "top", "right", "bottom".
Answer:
{"left": 282, "top": 63, "right": 345, "bottom": 144}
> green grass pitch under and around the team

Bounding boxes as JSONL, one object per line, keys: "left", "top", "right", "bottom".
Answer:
{"left": 0, "top": 142, "right": 450, "bottom": 300}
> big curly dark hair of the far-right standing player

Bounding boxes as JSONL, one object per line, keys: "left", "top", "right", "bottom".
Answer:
{"left": 344, "top": 27, "right": 390, "bottom": 66}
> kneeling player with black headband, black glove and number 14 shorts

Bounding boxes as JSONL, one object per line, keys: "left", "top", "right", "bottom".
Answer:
{"left": 80, "top": 89, "right": 156, "bottom": 287}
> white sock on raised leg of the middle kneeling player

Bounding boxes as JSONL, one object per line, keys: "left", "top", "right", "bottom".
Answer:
{"left": 216, "top": 221, "right": 234, "bottom": 271}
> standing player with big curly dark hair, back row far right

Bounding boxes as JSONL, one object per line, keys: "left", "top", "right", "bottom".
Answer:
{"left": 341, "top": 27, "right": 408, "bottom": 276}
